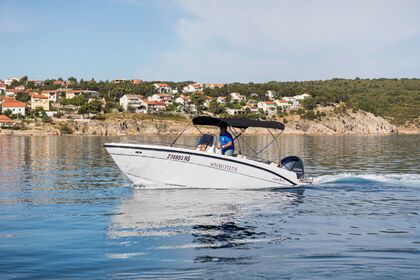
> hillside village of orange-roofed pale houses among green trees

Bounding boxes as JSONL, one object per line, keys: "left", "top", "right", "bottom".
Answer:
{"left": 0, "top": 76, "right": 311, "bottom": 128}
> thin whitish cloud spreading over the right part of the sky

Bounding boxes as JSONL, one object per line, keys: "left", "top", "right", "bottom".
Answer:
{"left": 142, "top": 0, "right": 420, "bottom": 81}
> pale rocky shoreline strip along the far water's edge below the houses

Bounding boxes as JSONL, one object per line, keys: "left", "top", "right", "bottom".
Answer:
{"left": 0, "top": 111, "right": 420, "bottom": 136}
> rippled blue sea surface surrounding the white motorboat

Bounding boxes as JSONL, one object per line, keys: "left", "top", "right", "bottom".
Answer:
{"left": 0, "top": 135, "right": 420, "bottom": 279}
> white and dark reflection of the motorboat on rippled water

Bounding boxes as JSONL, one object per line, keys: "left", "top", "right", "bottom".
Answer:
{"left": 108, "top": 189, "right": 304, "bottom": 249}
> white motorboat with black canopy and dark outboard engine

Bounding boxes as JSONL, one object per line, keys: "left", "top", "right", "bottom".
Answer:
{"left": 104, "top": 116, "right": 308, "bottom": 189}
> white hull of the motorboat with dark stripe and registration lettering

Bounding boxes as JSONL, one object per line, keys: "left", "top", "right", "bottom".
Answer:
{"left": 105, "top": 143, "right": 299, "bottom": 189}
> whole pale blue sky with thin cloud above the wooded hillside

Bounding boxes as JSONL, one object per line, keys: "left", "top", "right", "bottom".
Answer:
{"left": 0, "top": 0, "right": 420, "bottom": 82}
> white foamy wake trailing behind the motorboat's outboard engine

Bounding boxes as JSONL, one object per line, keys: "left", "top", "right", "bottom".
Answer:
{"left": 313, "top": 173, "right": 420, "bottom": 187}
